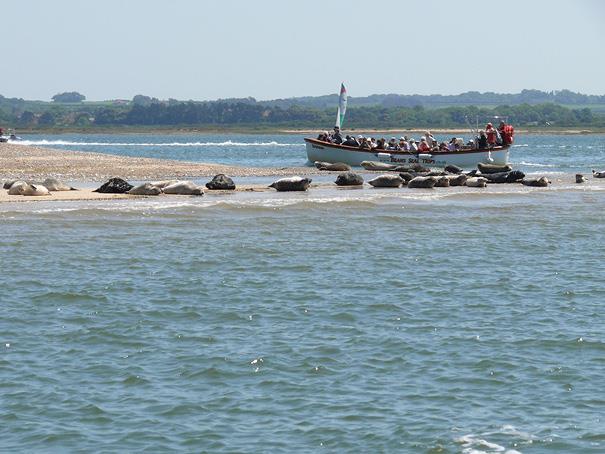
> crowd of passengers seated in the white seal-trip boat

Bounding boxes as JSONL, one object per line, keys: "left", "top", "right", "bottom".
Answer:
{"left": 317, "top": 121, "right": 514, "bottom": 153}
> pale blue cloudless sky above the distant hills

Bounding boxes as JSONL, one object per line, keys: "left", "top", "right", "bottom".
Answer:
{"left": 0, "top": 0, "right": 605, "bottom": 101}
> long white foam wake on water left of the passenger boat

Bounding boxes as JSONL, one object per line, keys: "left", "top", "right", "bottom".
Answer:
{"left": 14, "top": 139, "right": 305, "bottom": 147}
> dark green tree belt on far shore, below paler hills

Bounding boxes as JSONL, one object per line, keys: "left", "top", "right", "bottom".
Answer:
{"left": 0, "top": 100, "right": 605, "bottom": 129}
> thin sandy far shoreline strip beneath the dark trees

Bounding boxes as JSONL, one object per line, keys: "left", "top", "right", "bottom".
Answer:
{"left": 11, "top": 125, "right": 605, "bottom": 136}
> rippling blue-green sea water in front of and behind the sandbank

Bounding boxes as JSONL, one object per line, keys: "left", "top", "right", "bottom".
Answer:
{"left": 0, "top": 134, "right": 605, "bottom": 454}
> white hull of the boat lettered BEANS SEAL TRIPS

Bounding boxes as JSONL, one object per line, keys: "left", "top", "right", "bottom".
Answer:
{"left": 305, "top": 138, "right": 510, "bottom": 167}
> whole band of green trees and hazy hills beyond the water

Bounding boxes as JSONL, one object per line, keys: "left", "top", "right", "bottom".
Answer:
{"left": 0, "top": 90, "right": 605, "bottom": 131}
